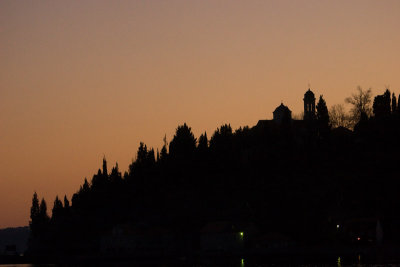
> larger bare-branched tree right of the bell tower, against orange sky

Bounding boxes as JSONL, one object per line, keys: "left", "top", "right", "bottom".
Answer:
{"left": 345, "top": 86, "right": 372, "bottom": 125}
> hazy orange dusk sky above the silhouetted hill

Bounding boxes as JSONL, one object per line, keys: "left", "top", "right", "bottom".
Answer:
{"left": 0, "top": 0, "right": 400, "bottom": 228}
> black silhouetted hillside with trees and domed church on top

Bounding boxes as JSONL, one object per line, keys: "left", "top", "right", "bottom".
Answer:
{"left": 28, "top": 89, "right": 400, "bottom": 262}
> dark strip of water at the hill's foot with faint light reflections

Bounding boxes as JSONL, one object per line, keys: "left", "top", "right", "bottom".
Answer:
{"left": 0, "top": 246, "right": 400, "bottom": 266}
